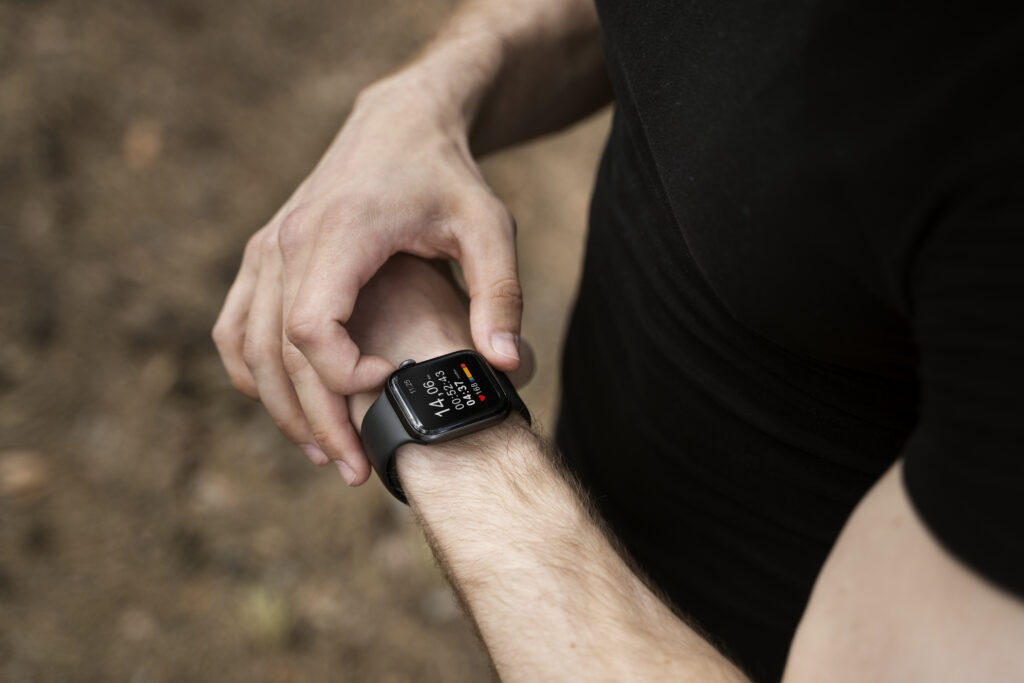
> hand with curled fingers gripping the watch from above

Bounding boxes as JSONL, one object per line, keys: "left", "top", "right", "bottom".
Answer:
{"left": 213, "top": 76, "right": 522, "bottom": 485}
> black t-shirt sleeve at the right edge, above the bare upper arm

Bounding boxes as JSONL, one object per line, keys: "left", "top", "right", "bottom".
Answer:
{"left": 903, "top": 164, "right": 1024, "bottom": 596}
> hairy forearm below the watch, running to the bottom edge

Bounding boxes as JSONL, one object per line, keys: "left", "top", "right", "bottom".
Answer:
{"left": 398, "top": 418, "right": 742, "bottom": 681}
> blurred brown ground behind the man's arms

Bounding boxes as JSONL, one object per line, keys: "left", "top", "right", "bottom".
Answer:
{"left": 0, "top": 0, "right": 607, "bottom": 683}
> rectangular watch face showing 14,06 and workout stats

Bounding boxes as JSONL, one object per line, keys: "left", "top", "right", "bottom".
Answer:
{"left": 388, "top": 351, "right": 509, "bottom": 436}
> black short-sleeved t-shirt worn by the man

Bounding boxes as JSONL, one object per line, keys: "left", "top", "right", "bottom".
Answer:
{"left": 558, "top": 0, "right": 1024, "bottom": 680}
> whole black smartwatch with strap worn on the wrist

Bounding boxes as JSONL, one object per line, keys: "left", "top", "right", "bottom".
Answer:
{"left": 362, "top": 351, "right": 530, "bottom": 505}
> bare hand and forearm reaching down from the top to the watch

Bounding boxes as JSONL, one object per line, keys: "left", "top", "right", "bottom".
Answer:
{"left": 213, "top": 0, "right": 610, "bottom": 485}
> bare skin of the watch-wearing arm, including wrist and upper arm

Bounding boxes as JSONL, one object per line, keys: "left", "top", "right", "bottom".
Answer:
{"left": 344, "top": 257, "right": 1024, "bottom": 682}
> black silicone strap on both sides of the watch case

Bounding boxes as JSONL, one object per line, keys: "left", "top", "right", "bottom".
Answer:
{"left": 362, "top": 368, "right": 532, "bottom": 505}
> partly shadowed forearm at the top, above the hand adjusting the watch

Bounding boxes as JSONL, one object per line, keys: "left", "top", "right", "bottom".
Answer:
{"left": 361, "top": 0, "right": 611, "bottom": 154}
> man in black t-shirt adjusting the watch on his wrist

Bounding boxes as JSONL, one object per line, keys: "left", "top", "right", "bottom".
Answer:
{"left": 214, "top": 0, "right": 1024, "bottom": 680}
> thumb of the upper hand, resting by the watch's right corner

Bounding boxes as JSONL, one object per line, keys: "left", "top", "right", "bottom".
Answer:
{"left": 460, "top": 212, "right": 522, "bottom": 372}
